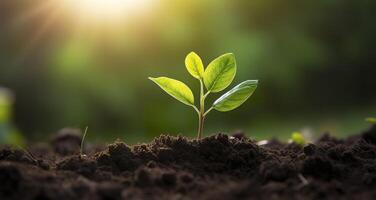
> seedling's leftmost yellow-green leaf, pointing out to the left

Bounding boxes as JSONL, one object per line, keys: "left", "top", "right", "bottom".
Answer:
{"left": 149, "top": 77, "right": 194, "bottom": 106}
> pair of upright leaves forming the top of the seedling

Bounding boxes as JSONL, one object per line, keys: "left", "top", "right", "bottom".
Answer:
{"left": 185, "top": 52, "right": 236, "bottom": 92}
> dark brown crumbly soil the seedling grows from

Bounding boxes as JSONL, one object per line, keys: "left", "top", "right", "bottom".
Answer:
{"left": 0, "top": 126, "right": 376, "bottom": 200}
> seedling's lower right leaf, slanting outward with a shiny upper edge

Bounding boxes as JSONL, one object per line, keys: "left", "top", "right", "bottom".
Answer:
{"left": 213, "top": 80, "right": 258, "bottom": 112}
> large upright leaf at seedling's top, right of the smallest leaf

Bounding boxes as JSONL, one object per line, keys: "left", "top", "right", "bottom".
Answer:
{"left": 204, "top": 53, "right": 236, "bottom": 92}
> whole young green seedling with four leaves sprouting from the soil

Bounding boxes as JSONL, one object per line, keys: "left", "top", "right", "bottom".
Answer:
{"left": 149, "top": 52, "right": 258, "bottom": 139}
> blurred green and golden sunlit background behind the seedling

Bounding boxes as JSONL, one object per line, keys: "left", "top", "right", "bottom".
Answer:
{"left": 0, "top": 0, "right": 376, "bottom": 143}
